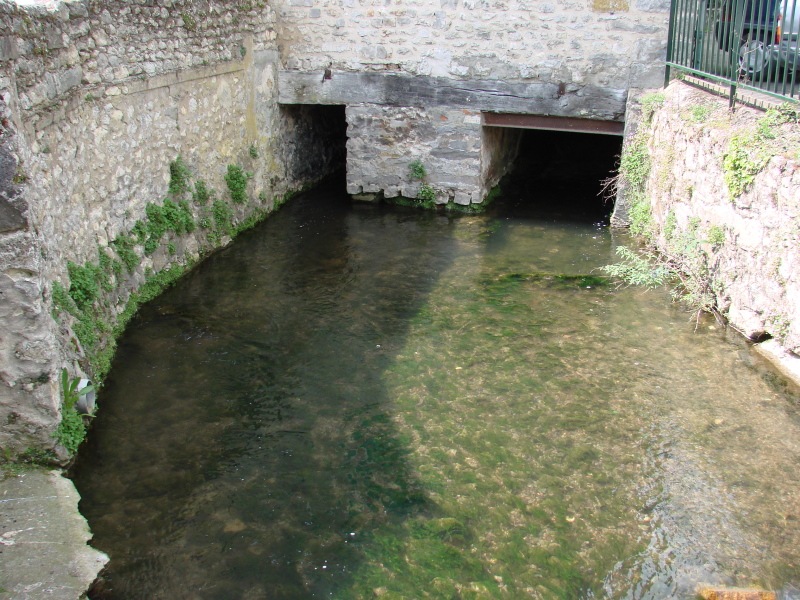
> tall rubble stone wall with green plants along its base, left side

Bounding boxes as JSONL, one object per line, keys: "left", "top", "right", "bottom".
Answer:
{"left": 0, "top": 0, "right": 343, "bottom": 452}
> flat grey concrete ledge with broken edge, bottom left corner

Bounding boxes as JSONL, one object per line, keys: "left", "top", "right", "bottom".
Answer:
{"left": 0, "top": 471, "right": 108, "bottom": 600}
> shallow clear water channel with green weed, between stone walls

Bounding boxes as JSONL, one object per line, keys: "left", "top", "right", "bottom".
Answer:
{"left": 73, "top": 135, "right": 800, "bottom": 600}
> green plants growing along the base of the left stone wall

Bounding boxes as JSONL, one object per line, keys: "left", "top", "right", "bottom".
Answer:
{"left": 52, "top": 156, "right": 306, "bottom": 422}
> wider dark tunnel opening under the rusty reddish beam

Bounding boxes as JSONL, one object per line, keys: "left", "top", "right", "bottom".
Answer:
{"left": 490, "top": 129, "right": 622, "bottom": 223}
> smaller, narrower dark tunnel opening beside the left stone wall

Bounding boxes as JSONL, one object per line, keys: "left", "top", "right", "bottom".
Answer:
{"left": 278, "top": 104, "right": 347, "bottom": 182}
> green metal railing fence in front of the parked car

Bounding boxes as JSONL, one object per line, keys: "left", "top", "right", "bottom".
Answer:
{"left": 666, "top": 0, "right": 800, "bottom": 105}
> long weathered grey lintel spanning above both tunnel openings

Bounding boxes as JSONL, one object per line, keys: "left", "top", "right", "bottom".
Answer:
{"left": 278, "top": 70, "right": 627, "bottom": 122}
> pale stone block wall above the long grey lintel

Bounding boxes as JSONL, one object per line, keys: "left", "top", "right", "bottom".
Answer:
{"left": 272, "top": 0, "right": 669, "bottom": 89}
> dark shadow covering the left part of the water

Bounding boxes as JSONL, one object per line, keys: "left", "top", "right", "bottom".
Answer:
{"left": 74, "top": 176, "right": 476, "bottom": 600}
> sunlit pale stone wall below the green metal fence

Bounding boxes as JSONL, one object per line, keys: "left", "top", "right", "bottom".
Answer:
{"left": 615, "top": 81, "right": 800, "bottom": 353}
